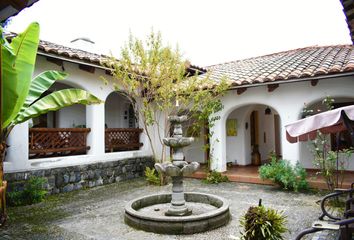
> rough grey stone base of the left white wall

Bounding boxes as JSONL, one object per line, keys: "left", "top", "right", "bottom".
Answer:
{"left": 4, "top": 157, "right": 154, "bottom": 194}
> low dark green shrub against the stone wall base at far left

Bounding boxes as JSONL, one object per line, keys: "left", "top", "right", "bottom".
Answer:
{"left": 7, "top": 177, "right": 48, "bottom": 206}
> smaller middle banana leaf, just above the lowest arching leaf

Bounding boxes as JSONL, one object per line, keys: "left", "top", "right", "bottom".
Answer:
{"left": 20, "top": 71, "right": 68, "bottom": 112}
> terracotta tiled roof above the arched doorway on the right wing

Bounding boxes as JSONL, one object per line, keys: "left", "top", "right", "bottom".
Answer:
{"left": 207, "top": 45, "right": 354, "bottom": 86}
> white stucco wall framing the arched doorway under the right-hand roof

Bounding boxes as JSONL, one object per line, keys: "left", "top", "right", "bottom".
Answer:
{"left": 211, "top": 76, "right": 354, "bottom": 171}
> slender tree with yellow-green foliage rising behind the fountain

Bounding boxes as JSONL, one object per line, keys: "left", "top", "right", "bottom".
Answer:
{"left": 106, "top": 32, "right": 227, "bottom": 162}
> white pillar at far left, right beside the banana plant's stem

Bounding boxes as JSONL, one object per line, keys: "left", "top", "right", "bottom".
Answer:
{"left": 4, "top": 122, "right": 30, "bottom": 172}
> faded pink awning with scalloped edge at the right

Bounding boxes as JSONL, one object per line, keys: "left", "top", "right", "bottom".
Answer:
{"left": 285, "top": 105, "right": 354, "bottom": 143}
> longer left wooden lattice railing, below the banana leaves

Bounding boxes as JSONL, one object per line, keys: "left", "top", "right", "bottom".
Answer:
{"left": 29, "top": 128, "right": 91, "bottom": 158}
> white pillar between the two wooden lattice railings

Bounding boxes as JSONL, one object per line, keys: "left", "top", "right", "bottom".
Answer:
{"left": 86, "top": 103, "right": 105, "bottom": 155}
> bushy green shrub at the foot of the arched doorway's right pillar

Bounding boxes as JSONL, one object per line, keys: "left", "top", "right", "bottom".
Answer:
{"left": 259, "top": 157, "right": 308, "bottom": 192}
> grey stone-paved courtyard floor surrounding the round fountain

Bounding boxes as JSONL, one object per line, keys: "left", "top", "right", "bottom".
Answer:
{"left": 0, "top": 179, "right": 334, "bottom": 240}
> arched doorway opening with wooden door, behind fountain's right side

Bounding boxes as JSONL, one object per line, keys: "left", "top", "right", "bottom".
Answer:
{"left": 225, "top": 104, "right": 281, "bottom": 166}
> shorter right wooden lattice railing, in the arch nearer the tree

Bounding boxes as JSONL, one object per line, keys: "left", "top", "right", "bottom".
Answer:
{"left": 105, "top": 128, "right": 143, "bottom": 152}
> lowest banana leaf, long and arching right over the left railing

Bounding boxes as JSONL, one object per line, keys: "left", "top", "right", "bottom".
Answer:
{"left": 13, "top": 88, "right": 102, "bottom": 124}
